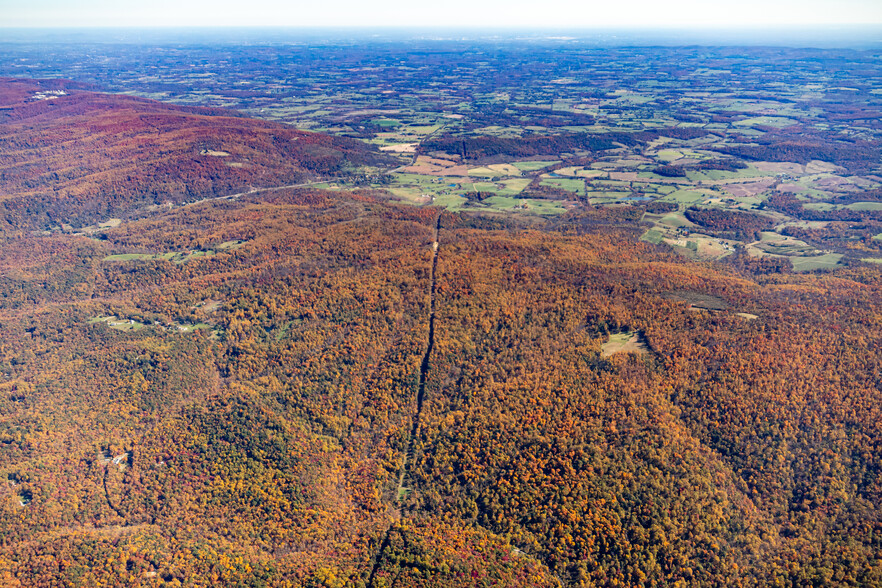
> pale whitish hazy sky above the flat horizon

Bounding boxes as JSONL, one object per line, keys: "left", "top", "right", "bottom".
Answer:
{"left": 0, "top": 0, "right": 882, "bottom": 28}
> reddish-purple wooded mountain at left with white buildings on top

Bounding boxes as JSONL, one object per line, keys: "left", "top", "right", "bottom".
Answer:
{"left": 0, "top": 78, "right": 382, "bottom": 229}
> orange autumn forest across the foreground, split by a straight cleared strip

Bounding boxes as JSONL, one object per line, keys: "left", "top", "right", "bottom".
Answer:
{"left": 0, "top": 80, "right": 882, "bottom": 588}
